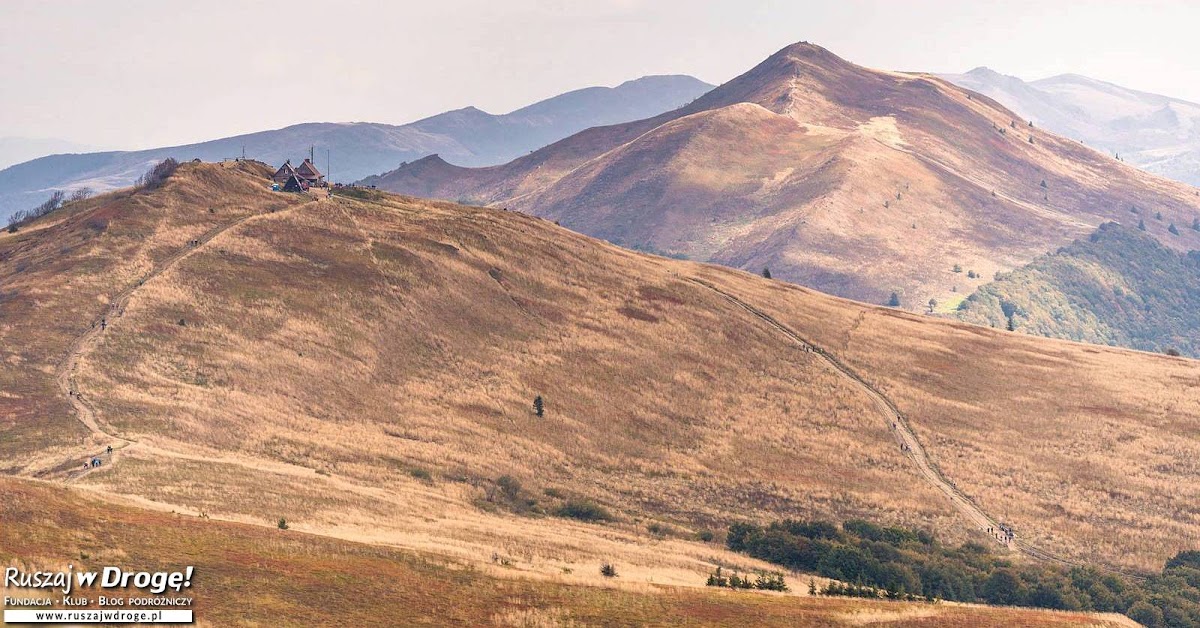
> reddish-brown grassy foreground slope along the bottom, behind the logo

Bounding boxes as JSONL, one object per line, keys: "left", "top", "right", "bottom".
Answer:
{"left": 0, "top": 478, "right": 1127, "bottom": 627}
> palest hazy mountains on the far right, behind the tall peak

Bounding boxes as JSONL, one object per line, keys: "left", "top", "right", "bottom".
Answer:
{"left": 942, "top": 67, "right": 1200, "bottom": 185}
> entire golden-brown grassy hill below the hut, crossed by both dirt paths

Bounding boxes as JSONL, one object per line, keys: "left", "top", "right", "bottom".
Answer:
{"left": 7, "top": 163, "right": 1200, "bottom": 605}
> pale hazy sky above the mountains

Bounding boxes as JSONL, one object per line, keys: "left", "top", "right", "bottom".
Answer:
{"left": 7, "top": 0, "right": 1200, "bottom": 148}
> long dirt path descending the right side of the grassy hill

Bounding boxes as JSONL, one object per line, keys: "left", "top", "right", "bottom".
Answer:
{"left": 688, "top": 277, "right": 1142, "bottom": 580}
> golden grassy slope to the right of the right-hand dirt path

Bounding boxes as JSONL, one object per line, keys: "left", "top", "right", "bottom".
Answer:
{"left": 706, "top": 270, "right": 1200, "bottom": 569}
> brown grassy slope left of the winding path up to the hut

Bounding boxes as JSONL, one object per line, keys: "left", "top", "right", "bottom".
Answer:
{"left": 0, "top": 163, "right": 300, "bottom": 472}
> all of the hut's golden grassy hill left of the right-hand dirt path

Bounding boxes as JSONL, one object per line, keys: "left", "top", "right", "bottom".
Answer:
{"left": 0, "top": 163, "right": 955, "bottom": 595}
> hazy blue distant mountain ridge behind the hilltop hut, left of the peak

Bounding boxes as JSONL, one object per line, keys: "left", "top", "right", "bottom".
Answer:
{"left": 0, "top": 76, "right": 712, "bottom": 220}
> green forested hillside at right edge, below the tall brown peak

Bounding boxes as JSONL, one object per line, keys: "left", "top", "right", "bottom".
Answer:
{"left": 959, "top": 222, "right": 1200, "bottom": 357}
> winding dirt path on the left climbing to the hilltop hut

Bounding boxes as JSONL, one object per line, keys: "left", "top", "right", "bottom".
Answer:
{"left": 55, "top": 196, "right": 316, "bottom": 483}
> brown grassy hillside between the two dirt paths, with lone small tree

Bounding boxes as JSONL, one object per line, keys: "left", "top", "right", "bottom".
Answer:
{"left": 63, "top": 166, "right": 954, "bottom": 533}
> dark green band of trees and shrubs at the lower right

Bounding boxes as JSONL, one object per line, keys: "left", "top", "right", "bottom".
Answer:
{"left": 726, "top": 520, "right": 1200, "bottom": 628}
